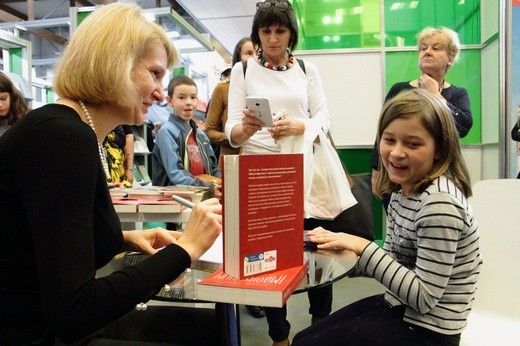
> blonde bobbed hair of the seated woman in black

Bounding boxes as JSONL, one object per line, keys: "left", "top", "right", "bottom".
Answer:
{"left": 54, "top": 3, "right": 178, "bottom": 108}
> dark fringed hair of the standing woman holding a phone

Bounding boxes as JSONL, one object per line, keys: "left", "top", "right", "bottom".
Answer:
{"left": 251, "top": 0, "right": 298, "bottom": 52}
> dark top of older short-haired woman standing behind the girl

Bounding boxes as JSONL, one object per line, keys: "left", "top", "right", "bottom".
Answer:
{"left": 370, "top": 82, "right": 473, "bottom": 170}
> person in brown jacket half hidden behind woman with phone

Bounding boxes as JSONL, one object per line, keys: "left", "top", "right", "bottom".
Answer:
{"left": 206, "top": 37, "right": 255, "bottom": 162}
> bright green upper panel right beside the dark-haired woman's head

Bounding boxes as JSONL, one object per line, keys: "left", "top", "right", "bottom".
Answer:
{"left": 292, "top": 0, "right": 381, "bottom": 50}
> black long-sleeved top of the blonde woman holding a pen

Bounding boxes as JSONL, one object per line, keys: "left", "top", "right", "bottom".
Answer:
{"left": 0, "top": 104, "right": 190, "bottom": 344}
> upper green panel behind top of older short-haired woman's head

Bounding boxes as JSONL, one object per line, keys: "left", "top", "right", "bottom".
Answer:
{"left": 384, "top": 0, "right": 480, "bottom": 47}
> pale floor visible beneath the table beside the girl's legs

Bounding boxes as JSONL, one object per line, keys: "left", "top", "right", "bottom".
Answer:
{"left": 240, "top": 278, "right": 383, "bottom": 346}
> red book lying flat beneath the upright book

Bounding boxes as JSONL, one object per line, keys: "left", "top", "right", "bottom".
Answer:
{"left": 197, "top": 264, "right": 307, "bottom": 307}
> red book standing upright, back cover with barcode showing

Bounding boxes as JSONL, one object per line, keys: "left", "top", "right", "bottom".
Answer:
{"left": 222, "top": 154, "right": 304, "bottom": 279}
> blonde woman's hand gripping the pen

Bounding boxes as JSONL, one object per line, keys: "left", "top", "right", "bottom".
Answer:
{"left": 177, "top": 198, "right": 222, "bottom": 261}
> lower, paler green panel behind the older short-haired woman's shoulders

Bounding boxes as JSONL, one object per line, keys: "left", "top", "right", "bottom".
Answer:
{"left": 385, "top": 49, "right": 481, "bottom": 144}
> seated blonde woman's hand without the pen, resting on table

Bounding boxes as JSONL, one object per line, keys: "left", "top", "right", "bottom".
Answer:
{"left": 123, "top": 227, "right": 181, "bottom": 255}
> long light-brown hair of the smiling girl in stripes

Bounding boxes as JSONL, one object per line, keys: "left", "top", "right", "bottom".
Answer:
{"left": 374, "top": 88, "right": 471, "bottom": 197}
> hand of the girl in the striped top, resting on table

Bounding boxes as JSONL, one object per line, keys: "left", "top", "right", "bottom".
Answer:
{"left": 307, "top": 227, "right": 370, "bottom": 256}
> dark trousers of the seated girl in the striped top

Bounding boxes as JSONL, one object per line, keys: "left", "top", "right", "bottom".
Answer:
{"left": 292, "top": 294, "right": 460, "bottom": 346}
